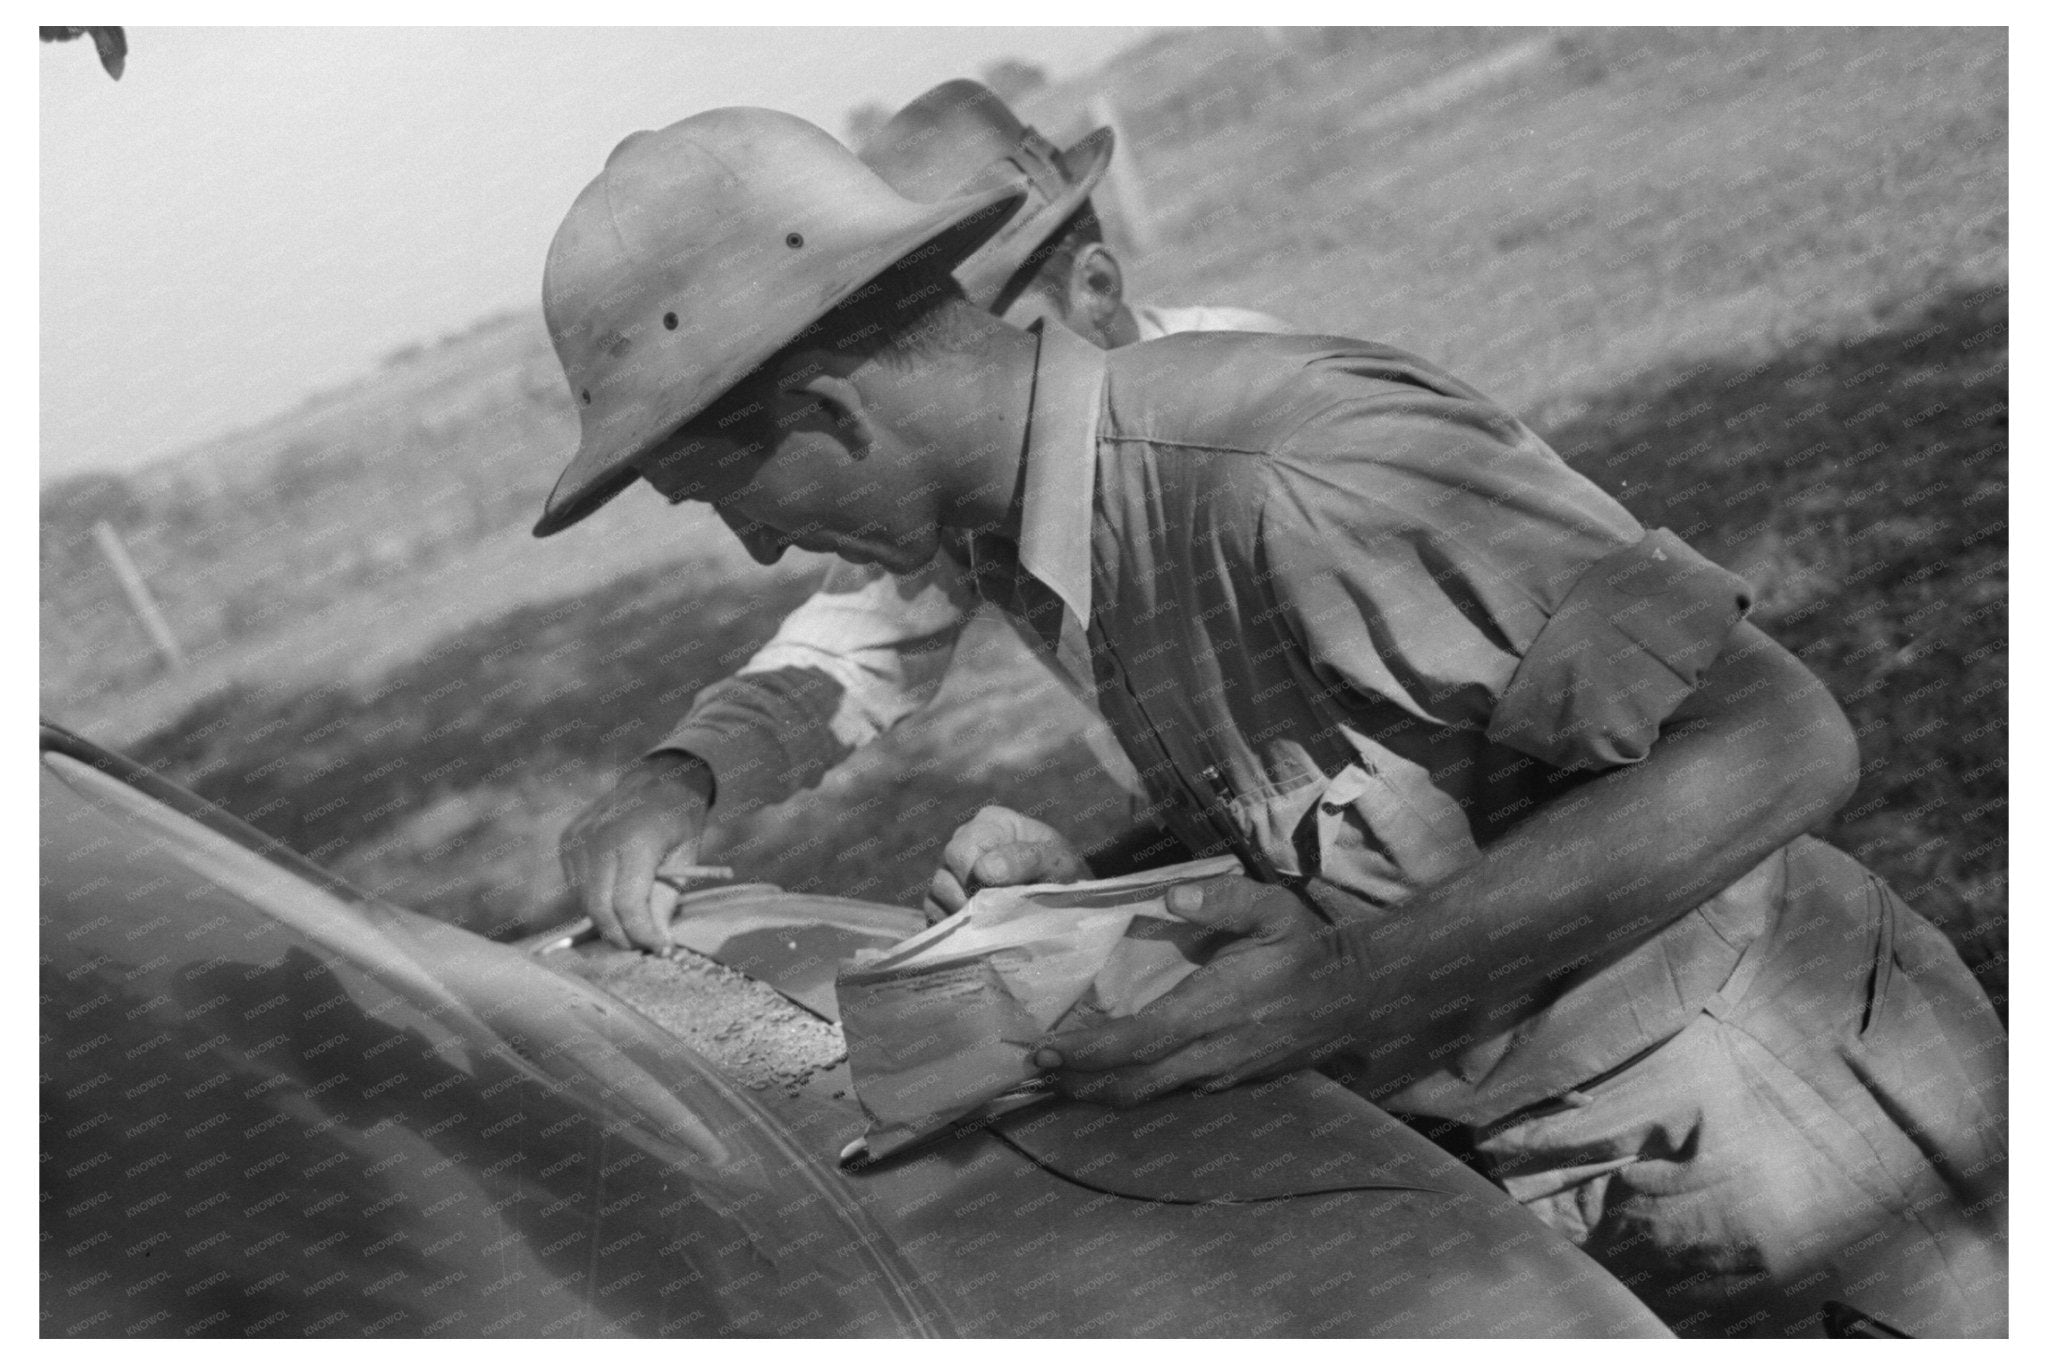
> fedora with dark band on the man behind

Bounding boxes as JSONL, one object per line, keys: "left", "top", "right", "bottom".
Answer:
{"left": 860, "top": 80, "right": 1116, "bottom": 307}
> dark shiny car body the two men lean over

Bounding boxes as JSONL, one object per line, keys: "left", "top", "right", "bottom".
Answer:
{"left": 41, "top": 726, "right": 1665, "bottom": 1336}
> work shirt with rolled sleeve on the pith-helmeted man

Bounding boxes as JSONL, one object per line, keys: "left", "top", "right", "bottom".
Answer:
{"left": 680, "top": 323, "right": 1784, "bottom": 1124}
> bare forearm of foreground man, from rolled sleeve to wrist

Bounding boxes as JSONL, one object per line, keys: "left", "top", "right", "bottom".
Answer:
{"left": 1311, "top": 636, "right": 1855, "bottom": 1085}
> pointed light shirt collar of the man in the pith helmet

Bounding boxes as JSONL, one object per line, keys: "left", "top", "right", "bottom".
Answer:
{"left": 1018, "top": 319, "right": 1110, "bottom": 630}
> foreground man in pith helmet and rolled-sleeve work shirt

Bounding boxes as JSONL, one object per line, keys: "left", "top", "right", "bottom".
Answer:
{"left": 541, "top": 111, "right": 2005, "bottom": 1334}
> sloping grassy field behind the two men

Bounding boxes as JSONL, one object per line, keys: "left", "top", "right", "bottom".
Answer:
{"left": 56, "top": 31, "right": 2007, "bottom": 1015}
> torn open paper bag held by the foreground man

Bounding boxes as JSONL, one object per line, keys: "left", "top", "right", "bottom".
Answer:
{"left": 838, "top": 857, "right": 1243, "bottom": 1158}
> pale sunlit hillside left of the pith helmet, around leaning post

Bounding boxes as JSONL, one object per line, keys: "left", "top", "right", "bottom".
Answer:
{"left": 41, "top": 311, "right": 817, "bottom": 743}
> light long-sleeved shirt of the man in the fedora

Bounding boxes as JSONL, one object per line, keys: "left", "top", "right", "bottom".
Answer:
{"left": 655, "top": 305, "right": 1294, "bottom": 808}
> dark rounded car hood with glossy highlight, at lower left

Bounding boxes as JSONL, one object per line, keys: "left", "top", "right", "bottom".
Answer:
{"left": 41, "top": 753, "right": 950, "bottom": 1334}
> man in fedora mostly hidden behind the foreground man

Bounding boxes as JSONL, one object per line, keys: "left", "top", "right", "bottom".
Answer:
{"left": 563, "top": 80, "right": 1290, "bottom": 950}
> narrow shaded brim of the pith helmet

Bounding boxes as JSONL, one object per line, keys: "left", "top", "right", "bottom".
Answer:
{"left": 532, "top": 184, "right": 1024, "bottom": 538}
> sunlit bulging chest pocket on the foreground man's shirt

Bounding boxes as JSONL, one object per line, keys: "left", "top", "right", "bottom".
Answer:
{"left": 1315, "top": 741, "right": 1479, "bottom": 905}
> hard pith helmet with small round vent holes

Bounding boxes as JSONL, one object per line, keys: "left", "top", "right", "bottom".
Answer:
{"left": 532, "top": 108, "right": 1022, "bottom": 536}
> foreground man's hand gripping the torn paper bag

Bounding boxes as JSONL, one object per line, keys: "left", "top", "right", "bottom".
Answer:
{"left": 1036, "top": 878, "right": 1362, "bottom": 1107}
